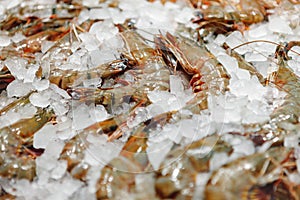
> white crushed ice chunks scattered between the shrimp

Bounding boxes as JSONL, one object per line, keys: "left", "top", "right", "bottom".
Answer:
{"left": 0, "top": 0, "right": 300, "bottom": 199}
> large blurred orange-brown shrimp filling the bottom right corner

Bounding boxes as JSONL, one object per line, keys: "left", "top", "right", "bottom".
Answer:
{"left": 205, "top": 147, "right": 300, "bottom": 200}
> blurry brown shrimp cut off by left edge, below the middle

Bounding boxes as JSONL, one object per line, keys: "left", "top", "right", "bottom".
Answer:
{"left": 0, "top": 108, "right": 53, "bottom": 180}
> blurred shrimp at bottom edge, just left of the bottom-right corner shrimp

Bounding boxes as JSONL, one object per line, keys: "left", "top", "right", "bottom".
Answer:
{"left": 155, "top": 134, "right": 233, "bottom": 199}
